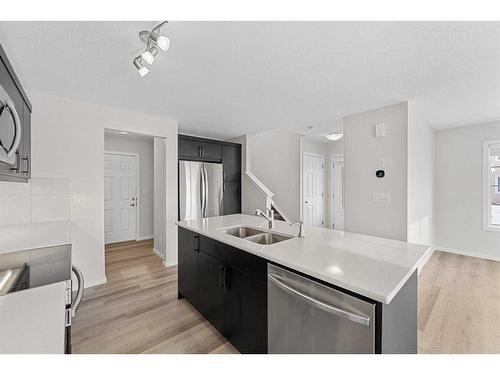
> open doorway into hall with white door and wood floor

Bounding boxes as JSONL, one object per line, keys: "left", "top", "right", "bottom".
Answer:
{"left": 103, "top": 129, "right": 166, "bottom": 272}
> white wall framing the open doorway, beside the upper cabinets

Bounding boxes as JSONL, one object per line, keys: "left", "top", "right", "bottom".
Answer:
{"left": 28, "top": 91, "right": 177, "bottom": 286}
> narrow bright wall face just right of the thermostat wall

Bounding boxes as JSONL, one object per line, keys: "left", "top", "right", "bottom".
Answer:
{"left": 407, "top": 101, "right": 435, "bottom": 246}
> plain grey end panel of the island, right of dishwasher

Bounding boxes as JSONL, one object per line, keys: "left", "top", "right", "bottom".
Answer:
{"left": 381, "top": 271, "right": 418, "bottom": 354}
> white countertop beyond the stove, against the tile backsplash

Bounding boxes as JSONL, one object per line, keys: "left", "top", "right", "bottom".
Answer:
{"left": 0, "top": 220, "right": 71, "bottom": 254}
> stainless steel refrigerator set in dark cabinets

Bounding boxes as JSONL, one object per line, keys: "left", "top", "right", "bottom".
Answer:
{"left": 179, "top": 161, "right": 224, "bottom": 220}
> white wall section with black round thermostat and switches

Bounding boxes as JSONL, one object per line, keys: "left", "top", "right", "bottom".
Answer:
{"left": 343, "top": 103, "right": 407, "bottom": 241}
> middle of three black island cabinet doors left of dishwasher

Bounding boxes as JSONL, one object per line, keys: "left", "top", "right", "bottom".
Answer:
{"left": 198, "top": 251, "right": 223, "bottom": 332}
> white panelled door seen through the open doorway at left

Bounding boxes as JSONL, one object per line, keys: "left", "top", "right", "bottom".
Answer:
{"left": 104, "top": 153, "right": 137, "bottom": 244}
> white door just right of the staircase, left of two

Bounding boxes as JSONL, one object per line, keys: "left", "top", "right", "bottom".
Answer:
{"left": 302, "top": 153, "right": 325, "bottom": 226}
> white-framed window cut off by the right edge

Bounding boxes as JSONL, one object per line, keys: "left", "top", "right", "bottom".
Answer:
{"left": 483, "top": 140, "right": 500, "bottom": 231}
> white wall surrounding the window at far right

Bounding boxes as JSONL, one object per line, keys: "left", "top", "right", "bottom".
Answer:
{"left": 435, "top": 122, "right": 500, "bottom": 260}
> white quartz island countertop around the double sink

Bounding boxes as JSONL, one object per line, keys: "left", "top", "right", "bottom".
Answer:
{"left": 177, "top": 214, "right": 431, "bottom": 304}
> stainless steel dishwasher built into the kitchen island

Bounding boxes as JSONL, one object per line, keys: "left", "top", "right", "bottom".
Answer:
{"left": 267, "top": 264, "right": 375, "bottom": 354}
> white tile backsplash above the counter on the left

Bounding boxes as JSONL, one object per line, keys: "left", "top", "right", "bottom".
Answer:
{"left": 0, "top": 178, "right": 71, "bottom": 225}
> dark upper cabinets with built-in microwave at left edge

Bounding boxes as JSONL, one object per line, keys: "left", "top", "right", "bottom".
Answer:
{"left": 0, "top": 45, "right": 31, "bottom": 182}
